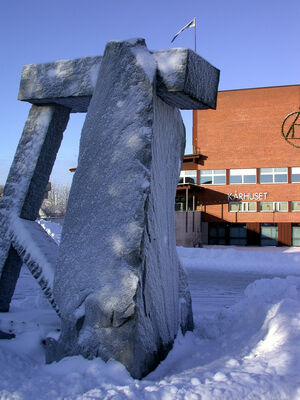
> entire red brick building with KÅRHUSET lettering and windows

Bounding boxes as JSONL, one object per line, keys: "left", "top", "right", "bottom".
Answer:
{"left": 176, "top": 85, "right": 300, "bottom": 246}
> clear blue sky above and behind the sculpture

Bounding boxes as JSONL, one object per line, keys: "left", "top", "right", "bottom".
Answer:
{"left": 0, "top": 0, "right": 300, "bottom": 184}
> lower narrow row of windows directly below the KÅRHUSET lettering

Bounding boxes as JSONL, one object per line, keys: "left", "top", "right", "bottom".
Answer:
{"left": 228, "top": 201, "right": 300, "bottom": 212}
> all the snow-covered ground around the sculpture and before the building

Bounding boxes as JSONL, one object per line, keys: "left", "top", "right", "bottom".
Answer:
{"left": 0, "top": 222, "right": 300, "bottom": 400}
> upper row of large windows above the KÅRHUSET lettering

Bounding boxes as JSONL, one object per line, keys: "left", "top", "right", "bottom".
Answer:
{"left": 179, "top": 167, "right": 300, "bottom": 185}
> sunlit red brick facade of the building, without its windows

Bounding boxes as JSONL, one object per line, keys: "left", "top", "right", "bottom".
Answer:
{"left": 183, "top": 85, "right": 300, "bottom": 245}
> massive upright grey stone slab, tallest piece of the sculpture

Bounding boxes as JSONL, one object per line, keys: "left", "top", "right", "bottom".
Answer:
{"left": 47, "top": 39, "right": 193, "bottom": 378}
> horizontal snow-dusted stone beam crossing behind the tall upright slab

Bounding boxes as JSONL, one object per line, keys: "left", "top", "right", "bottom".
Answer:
{"left": 18, "top": 48, "right": 220, "bottom": 112}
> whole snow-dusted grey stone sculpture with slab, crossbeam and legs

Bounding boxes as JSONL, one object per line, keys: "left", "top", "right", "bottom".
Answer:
{"left": 0, "top": 39, "right": 219, "bottom": 378}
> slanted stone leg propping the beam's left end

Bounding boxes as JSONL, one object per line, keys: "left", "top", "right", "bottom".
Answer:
{"left": 0, "top": 105, "right": 70, "bottom": 310}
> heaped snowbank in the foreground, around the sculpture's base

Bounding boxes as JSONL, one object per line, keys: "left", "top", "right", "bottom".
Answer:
{"left": 0, "top": 277, "right": 300, "bottom": 400}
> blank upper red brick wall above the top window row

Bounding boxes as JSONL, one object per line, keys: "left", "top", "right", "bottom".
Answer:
{"left": 193, "top": 85, "right": 300, "bottom": 169}
